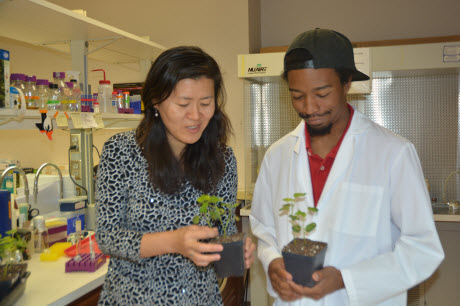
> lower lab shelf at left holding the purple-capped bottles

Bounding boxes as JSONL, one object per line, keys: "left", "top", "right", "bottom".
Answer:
{"left": 0, "top": 108, "right": 144, "bottom": 130}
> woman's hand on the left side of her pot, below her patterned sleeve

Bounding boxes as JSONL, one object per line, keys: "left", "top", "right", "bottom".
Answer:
{"left": 172, "top": 225, "right": 223, "bottom": 267}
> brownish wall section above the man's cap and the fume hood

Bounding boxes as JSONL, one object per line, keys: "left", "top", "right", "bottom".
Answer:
{"left": 261, "top": 0, "right": 460, "bottom": 47}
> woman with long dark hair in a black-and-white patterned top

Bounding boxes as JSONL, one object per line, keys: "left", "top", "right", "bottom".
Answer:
{"left": 96, "top": 47, "right": 255, "bottom": 305}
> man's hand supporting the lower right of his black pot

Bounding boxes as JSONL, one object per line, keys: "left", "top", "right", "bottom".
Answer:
{"left": 290, "top": 267, "right": 345, "bottom": 300}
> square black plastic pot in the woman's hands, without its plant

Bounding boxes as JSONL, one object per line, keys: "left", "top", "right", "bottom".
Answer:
{"left": 214, "top": 239, "right": 244, "bottom": 278}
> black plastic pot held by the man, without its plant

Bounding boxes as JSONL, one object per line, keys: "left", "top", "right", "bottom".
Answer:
{"left": 282, "top": 241, "right": 327, "bottom": 288}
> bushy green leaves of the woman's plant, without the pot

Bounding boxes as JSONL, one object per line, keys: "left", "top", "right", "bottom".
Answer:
{"left": 193, "top": 194, "right": 239, "bottom": 236}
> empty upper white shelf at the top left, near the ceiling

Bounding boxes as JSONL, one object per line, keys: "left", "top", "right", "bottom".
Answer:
{"left": 0, "top": 0, "right": 165, "bottom": 63}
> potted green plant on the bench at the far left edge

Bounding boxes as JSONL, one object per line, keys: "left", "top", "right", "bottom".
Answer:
{"left": 0, "top": 231, "right": 30, "bottom": 305}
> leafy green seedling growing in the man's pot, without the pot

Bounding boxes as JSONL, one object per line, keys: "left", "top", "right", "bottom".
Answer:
{"left": 280, "top": 193, "right": 318, "bottom": 239}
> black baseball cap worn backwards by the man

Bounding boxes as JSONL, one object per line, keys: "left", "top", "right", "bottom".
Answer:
{"left": 284, "top": 28, "right": 369, "bottom": 81}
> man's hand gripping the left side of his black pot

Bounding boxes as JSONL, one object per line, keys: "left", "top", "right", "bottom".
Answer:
{"left": 268, "top": 257, "right": 302, "bottom": 301}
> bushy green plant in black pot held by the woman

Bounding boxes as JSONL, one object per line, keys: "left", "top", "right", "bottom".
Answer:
{"left": 193, "top": 194, "right": 245, "bottom": 278}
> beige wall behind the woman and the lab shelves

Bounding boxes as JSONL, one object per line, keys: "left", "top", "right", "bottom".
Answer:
{"left": 0, "top": 0, "right": 251, "bottom": 188}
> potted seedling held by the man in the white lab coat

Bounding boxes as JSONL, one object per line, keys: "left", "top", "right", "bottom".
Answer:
{"left": 280, "top": 193, "right": 327, "bottom": 287}
